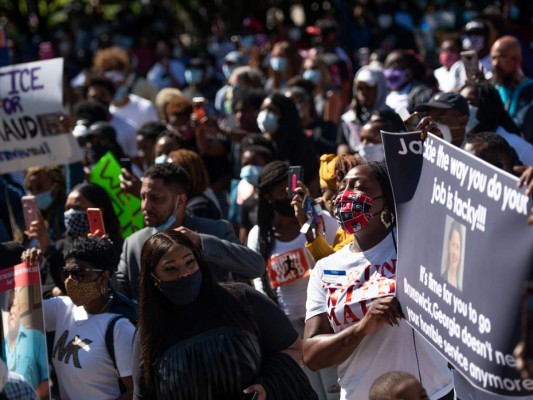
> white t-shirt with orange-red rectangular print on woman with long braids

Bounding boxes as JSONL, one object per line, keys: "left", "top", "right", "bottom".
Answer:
{"left": 248, "top": 212, "right": 338, "bottom": 321}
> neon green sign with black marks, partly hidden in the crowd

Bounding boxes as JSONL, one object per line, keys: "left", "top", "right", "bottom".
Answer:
{"left": 90, "top": 152, "right": 144, "bottom": 238}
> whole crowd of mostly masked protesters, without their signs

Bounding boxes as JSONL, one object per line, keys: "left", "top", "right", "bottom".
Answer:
{"left": 0, "top": 0, "right": 533, "bottom": 400}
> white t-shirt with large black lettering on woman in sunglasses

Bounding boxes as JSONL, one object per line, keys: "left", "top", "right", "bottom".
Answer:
{"left": 43, "top": 296, "right": 135, "bottom": 400}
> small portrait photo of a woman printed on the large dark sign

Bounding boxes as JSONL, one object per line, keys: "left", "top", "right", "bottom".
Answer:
{"left": 441, "top": 217, "right": 465, "bottom": 290}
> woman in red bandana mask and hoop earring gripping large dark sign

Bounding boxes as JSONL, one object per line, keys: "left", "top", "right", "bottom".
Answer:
{"left": 304, "top": 163, "right": 453, "bottom": 400}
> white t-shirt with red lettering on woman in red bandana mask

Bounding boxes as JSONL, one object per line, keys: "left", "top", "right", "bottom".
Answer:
{"left": 306, "top": 234, "right": 453, "bottom": 400}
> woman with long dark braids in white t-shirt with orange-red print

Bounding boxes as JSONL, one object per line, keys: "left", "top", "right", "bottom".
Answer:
{"left": 248, "top": 161, "right": 337, "bottom": 399}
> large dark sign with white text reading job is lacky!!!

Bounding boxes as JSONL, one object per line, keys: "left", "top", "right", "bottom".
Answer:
{"left": 382, "top": 132, "right": 533, "bottom": 396}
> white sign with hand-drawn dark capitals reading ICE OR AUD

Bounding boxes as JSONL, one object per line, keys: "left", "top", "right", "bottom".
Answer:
{"left": 0, "top": 58, "right": 82, "bottom": 174}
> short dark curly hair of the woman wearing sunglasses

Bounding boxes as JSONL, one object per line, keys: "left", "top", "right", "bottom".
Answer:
{"left": 63, "top": 236, "right": 118, "bottom": 275}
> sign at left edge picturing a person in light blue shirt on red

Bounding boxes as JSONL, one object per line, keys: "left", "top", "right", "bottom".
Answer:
{"left": 0, "top": 263, "right": 49, "bottom": 389}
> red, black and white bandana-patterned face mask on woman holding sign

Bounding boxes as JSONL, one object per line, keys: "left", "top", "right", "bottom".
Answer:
{"left": 335, "top": 189, "right": 374, "bottom": 235}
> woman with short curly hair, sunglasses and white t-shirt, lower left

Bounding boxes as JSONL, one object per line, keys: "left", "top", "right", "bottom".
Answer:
{"left": 44, "top": 237, "right": 136, "bottom": 400}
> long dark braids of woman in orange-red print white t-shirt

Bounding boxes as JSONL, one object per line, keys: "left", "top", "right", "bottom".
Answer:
{"left": 257, "top": 161, "right": 289, "bottom": 301}
